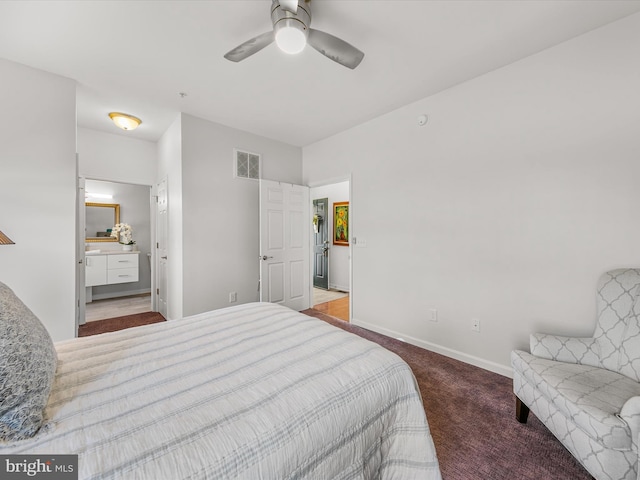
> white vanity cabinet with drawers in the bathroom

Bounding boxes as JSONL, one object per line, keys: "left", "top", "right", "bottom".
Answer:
{"left": 85, "top": 253, "right": 139, "bottom": 287}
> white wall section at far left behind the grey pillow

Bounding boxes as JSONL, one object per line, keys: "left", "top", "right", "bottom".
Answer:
{"left": 0, "top": 59, "right": 76, "bottom": 341}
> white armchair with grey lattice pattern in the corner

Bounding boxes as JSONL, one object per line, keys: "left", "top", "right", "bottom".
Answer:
{"left": 511, "top": 269, "right": 640, "bottom": 480}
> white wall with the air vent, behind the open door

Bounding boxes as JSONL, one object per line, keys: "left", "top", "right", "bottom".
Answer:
{"left": 179, "top": 115, "right": 302, "bottom": 315}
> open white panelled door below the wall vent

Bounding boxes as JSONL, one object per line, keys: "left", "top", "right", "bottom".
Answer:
{"left": 260, "top": 180, "right": 311, "bottom": 311}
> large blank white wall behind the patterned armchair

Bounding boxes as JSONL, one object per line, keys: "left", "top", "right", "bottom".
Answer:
{"left": 303, "top": 14, "right": 640, "bottom": 375}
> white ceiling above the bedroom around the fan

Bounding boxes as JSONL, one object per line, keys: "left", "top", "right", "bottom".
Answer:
{"left": 0, "top": 0, "right": 640, "bottom": 146}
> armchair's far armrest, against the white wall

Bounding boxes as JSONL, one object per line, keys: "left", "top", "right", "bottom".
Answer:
{"left": 529, "top": 333, "right": 601, "bottom": 367}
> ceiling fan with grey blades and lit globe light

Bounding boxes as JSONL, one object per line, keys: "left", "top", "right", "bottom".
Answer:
{"left": 224, "top": 0, "right": 364, "bottom": 69}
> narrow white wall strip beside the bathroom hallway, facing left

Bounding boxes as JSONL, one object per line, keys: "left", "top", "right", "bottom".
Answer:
{"left": 157, "top": 115, "right": 183, "bottom": 320}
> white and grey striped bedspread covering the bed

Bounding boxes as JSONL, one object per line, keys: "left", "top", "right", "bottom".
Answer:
{"left": 0, "top": 303, "right": 440, "bottom": 480}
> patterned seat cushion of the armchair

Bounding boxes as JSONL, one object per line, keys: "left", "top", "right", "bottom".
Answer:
{"left": 511, "top": 350, "right": 640, "bottom": 449}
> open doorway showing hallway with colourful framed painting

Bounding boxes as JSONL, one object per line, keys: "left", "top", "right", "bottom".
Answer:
{"left": 310, "top": 180, "right": 351, "bottom": 321}
